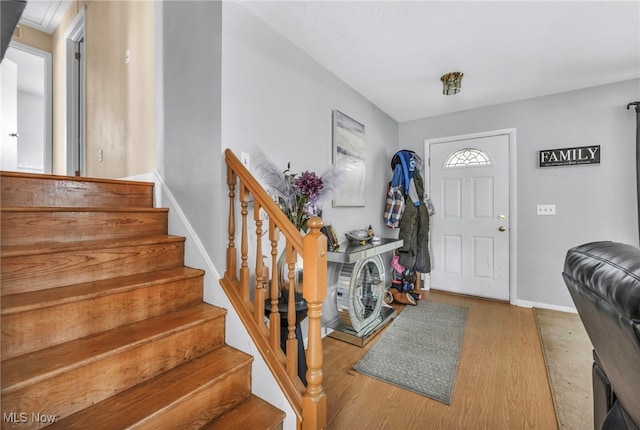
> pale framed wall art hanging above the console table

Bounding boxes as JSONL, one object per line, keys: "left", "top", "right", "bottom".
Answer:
{"left": 333, "top": 110, "right": 365, "bottom": 207}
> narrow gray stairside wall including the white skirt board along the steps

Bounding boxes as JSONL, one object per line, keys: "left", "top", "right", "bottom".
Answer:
{"left": 154, "top": 1, "right": 295, "bottom": 429}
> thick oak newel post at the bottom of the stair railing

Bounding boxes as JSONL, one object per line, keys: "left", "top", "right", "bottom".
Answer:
{"left": 302, "top": 217, "right": 327, "bottom": 430}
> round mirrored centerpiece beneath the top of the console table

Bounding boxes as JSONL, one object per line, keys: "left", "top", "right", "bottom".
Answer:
{"left": 337, "top": 255, "right": 385, "bottom": 333}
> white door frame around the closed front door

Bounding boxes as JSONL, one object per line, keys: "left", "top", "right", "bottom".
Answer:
{"left": 423, "top": 128, "right": 518, "bottom": 305}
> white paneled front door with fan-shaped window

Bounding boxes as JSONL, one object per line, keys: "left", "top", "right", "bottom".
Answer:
{"left": 427, "top": 134, "right": 510, "bottom": 300}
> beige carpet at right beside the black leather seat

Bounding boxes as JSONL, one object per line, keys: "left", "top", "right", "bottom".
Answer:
{"left": 533, "top": 308, "right": 593, "bottom": 430}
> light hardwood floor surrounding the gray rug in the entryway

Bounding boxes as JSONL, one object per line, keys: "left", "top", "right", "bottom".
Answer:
{"left": 323, "top": 291, "right": 558, "bottom": 430}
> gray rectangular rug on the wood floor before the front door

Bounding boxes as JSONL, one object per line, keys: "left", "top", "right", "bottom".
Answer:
{"left": 354, "top": 301, "right": 468, "bottom": 405}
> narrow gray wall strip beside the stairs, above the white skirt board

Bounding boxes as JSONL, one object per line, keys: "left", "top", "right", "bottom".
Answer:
{"left": 155, "top": 1, "right": 228, "bottom": 273}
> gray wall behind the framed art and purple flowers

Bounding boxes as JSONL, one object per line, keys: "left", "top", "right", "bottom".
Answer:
{"left": 222, "top": 2, "right": 398, "bottom": 239}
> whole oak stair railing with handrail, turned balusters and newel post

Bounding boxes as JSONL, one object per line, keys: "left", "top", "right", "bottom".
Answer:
{"left": 220, "top": 149, "right": 327, "bottom": 430}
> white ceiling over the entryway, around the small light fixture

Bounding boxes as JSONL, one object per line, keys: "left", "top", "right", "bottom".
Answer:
{"left": 238, "top": 0, "right": 640, "bottom": 122}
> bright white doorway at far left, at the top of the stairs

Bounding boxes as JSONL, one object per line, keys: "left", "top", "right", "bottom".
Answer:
{"left": 0, "top": 41, "right": 53, "bottom": 173}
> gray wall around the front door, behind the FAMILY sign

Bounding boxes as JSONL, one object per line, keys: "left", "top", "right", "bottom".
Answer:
{"left": 399, "top": 80, "right": 640, "bottom": 308}
